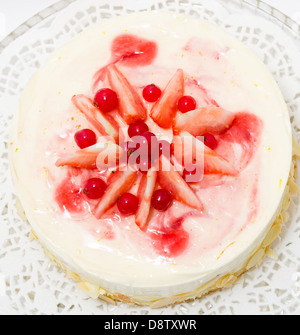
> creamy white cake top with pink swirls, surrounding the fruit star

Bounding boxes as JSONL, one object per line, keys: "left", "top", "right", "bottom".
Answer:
{"left": 11, "top": 13, "right": 292, "bottom": 287}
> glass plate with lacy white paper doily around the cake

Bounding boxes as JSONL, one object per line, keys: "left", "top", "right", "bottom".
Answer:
{"left": 0, "top": 0, "right": 300, "bottom": 315}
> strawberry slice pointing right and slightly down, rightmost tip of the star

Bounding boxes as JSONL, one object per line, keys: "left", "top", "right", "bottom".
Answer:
{"left": 173, "top": 131, "right": 238, "bottom": 176}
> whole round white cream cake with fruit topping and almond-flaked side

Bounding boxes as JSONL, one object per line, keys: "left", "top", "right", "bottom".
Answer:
{"left": 10, "top": 12, "right": 296, "bottom": 308}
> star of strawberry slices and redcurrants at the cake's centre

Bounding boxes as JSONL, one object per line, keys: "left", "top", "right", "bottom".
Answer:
{"left": 56, "top": 64, "right": 238, "bottom": 230}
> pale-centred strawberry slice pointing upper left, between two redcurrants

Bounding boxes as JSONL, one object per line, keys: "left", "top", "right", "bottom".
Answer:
{"left": 72, "top": 94, "right": 119, "bottom": 140}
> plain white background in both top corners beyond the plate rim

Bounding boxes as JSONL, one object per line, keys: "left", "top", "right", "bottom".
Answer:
{"left": 0, "top": 0, "right": 300, "bottom": 40}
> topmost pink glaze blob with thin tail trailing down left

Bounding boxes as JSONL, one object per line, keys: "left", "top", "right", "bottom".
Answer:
{"left": 93, "top": 34, "right": 158, "bottom": 89}
